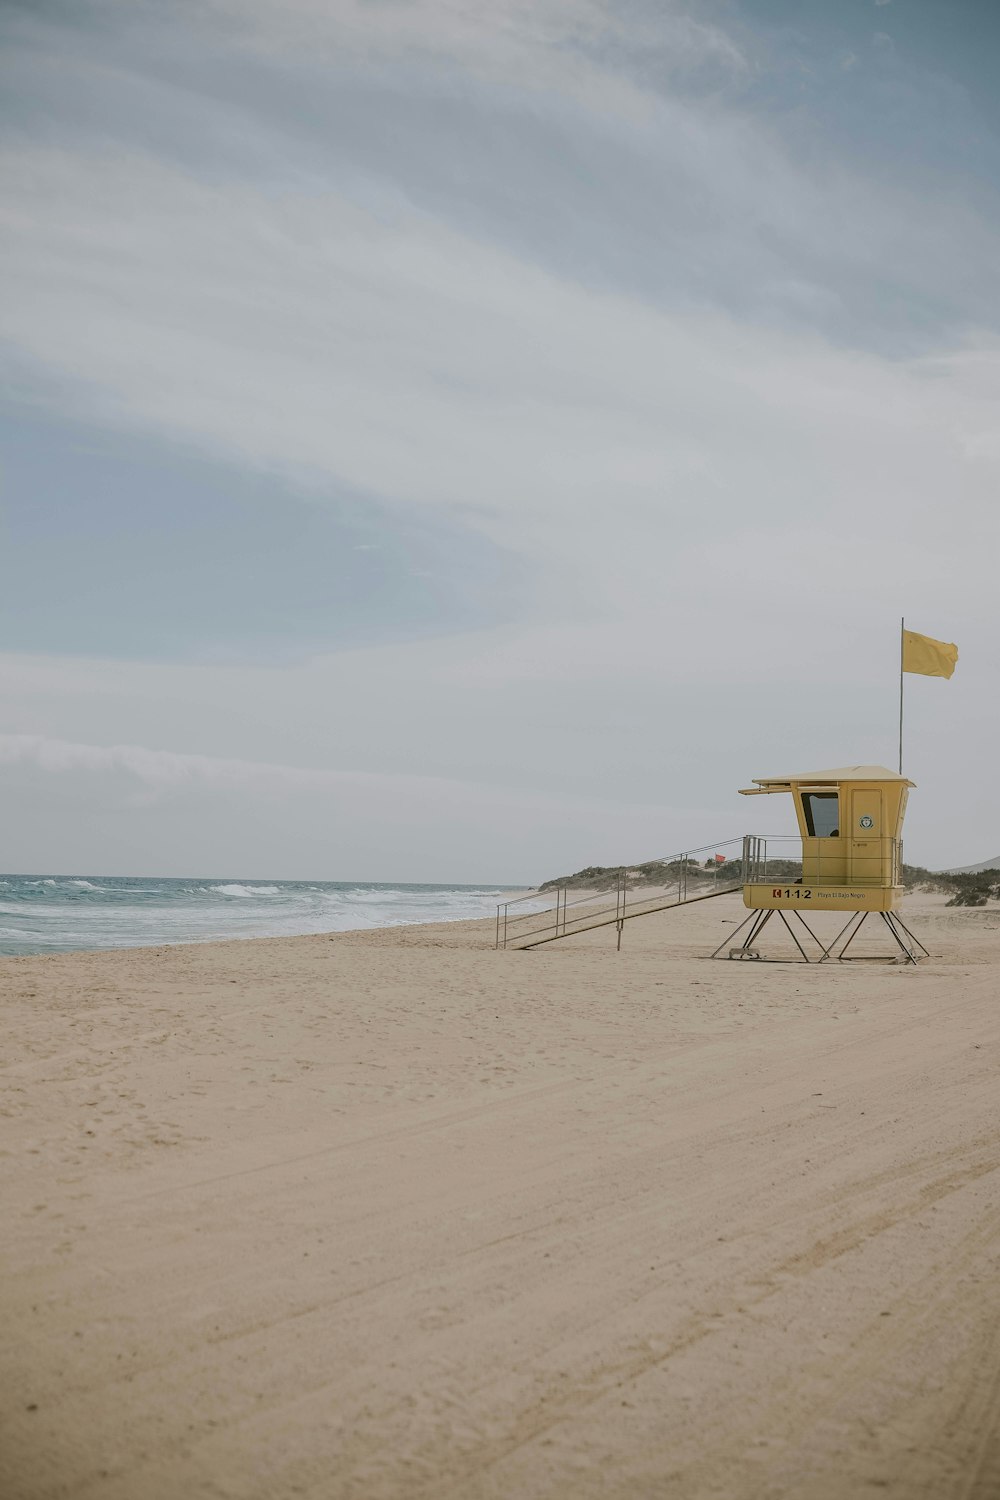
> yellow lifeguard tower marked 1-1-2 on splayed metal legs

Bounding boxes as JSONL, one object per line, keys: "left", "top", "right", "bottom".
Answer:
{"left": 717, "top": 765, "right": 927, "bottom": 963}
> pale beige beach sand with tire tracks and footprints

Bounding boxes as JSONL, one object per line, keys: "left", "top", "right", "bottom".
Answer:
{"left": 0, "top": 897, "right": 1000, "bottom": 1500}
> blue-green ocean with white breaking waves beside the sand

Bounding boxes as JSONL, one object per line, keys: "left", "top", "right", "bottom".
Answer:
{"left": 0, "top": 875, "right": 524, "bottom": 954}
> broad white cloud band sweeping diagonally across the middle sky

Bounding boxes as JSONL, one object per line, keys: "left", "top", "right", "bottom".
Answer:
{"left": 0, "top": 136, "right": 1000, "bottom": 639}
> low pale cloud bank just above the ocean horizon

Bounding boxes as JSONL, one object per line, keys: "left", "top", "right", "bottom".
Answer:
{"left": 0, "top": 735, "right": 749, "bottom": 884}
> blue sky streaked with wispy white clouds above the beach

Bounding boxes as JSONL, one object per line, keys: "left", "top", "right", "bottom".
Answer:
{"left": 0, "top": 0, "right": 1000, "bottom": 884}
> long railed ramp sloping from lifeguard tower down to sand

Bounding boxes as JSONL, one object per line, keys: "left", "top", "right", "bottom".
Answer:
{"left": 495, "top": 839, "right": 745, "bottom": 950}
